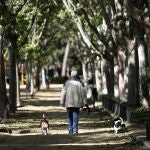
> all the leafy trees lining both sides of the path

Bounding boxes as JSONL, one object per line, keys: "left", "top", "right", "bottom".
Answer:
{"left": 0, "top": 0, "right": 150, "bottom": 117}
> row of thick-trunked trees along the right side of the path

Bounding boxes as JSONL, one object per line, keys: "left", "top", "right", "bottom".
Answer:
{"left": 63, "top": 0, "right": 150, "bottom": 107}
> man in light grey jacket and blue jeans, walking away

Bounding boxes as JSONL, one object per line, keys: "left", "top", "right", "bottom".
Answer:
{"left": 60, "top": 70, "right": 87, "bottom": 134}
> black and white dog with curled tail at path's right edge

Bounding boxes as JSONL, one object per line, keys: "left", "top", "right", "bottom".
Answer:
{"left": 113, "top": 117, "right": 126, "bottom": 134}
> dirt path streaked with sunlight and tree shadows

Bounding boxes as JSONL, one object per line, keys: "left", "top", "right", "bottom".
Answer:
{"left": 0, "top": 85, "right": 147, "bottom": 150}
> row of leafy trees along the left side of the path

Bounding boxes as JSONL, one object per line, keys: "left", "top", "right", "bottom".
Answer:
{"left": 0, "top": 0, "right": 67, "bottom": 117}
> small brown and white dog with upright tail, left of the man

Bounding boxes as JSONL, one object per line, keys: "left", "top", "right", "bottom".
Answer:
{"left": 40, "top": 114, "right": 49, "bottom": 135}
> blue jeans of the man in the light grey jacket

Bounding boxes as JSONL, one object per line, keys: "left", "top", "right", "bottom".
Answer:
{"left": 67, "top": 107, "right": 79, "bottom": 134}
